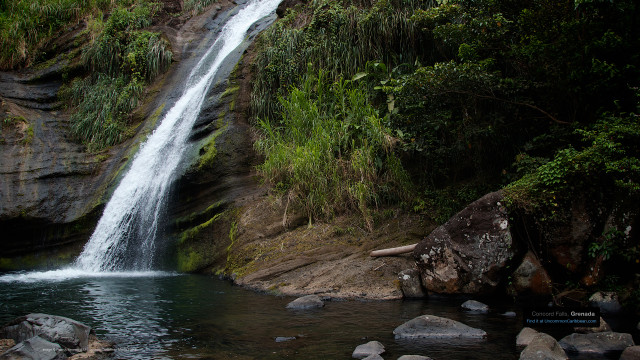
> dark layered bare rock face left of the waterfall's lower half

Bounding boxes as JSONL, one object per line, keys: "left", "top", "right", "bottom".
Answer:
{"left": 0, "top": 69, "right": 119, "bottom": 264}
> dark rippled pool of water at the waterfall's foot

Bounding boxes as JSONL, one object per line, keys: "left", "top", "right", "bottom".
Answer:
{"left": 0, "top": 274, "right": 624, "bottom": 360}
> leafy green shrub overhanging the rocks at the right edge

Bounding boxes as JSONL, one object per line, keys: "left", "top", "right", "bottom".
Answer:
{"left": 505, "top": 107, "right": 640, "bottom": 220}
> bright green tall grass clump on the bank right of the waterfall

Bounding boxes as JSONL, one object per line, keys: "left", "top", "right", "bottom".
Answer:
{"left": 255, "top": 70, "right": 410, "bottom": 229}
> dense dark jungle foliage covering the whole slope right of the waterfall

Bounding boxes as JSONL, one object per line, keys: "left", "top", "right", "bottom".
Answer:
{"left": 252, "top": 0, "right": 640, "bottom": 228}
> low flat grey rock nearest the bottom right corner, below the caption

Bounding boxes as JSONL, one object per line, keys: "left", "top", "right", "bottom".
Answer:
{"left": 560, "top": 331, "right": 635, "bottom": 355}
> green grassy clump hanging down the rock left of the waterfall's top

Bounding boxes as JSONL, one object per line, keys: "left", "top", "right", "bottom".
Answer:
{"left": 68, "top": 1, "right": 172, "bottom": 151}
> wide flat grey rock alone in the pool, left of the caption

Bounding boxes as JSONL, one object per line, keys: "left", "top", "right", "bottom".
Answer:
{"left": 393, "top": 315, "right": 487, "bottom": 339}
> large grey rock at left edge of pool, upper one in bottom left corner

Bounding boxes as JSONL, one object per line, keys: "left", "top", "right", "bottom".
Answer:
{"left": 0, "top": 314, "right": 91, "bottom": 352}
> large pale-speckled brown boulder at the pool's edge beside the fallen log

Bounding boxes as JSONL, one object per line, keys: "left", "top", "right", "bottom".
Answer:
{"left": 413, "top": 192, "right": 517, "bottom": 294}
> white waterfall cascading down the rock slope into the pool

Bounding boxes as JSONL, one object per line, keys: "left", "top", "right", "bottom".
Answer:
{"left": 75, "top": 0, "right": 281, "bottom": 272}
